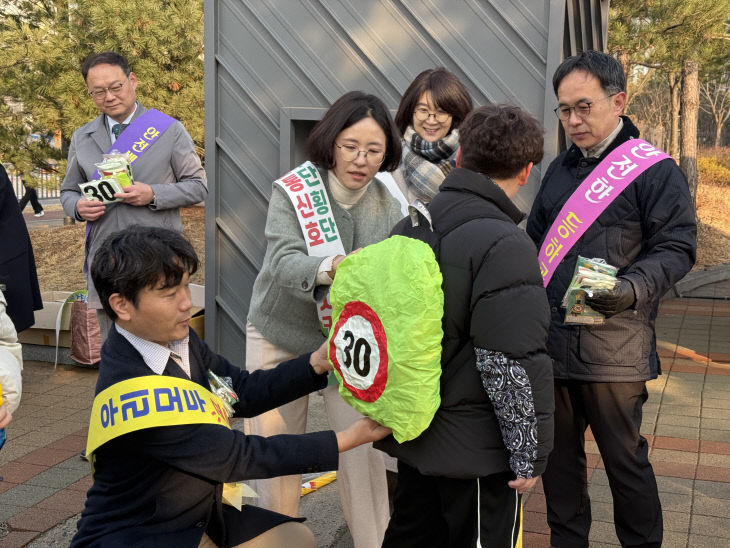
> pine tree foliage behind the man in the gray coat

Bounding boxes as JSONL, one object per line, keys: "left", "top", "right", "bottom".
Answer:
{"left": 0, "top": 0, "right": 204, "bottom": 183}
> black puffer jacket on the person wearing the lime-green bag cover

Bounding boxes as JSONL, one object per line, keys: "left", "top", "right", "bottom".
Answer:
{"left": 376, "top": 168, "right": 553, "bottom": 478}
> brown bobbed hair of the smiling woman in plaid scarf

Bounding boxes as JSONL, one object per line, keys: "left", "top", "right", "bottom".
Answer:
{"left": 395, "top": 67, "right": 472, "bottom": 135}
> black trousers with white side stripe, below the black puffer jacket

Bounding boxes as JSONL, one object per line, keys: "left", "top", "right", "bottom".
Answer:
{"left": 383, "top": 461, "right": 522, "bottom": 548}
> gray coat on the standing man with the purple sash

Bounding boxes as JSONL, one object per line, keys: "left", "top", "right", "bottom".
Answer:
{"left": 61, "top": 103, "right": 208, "bottom": 308}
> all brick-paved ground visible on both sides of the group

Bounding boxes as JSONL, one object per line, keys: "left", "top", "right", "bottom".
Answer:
{"left": 0, "top": 282, "right": 730, "bottom": 548}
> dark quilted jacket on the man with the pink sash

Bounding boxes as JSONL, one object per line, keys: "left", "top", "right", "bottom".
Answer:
{"left": 527, "top": 117, "right": 697, "bottom": 382}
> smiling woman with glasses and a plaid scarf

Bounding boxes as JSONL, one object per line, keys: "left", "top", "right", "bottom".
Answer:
{"left": 393, "top": 67, "right": 472, "bottom": 203}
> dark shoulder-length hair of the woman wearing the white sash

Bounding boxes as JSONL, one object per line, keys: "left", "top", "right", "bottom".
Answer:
{"left": 307, "top": 91, "right": 401, "bottom": 171}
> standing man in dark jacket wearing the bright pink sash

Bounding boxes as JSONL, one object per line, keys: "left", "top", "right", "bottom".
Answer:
{"left": 527, "top": 51, "right": 697, "bottom": 548}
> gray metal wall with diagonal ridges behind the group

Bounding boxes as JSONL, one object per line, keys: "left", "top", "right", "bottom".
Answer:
{"left": 205, "top": 0, "right": 608, "bottom": 363}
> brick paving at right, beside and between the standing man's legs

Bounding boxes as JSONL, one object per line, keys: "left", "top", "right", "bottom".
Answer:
{"left": 524, "top": 282, "right": 730, "bottom": 548}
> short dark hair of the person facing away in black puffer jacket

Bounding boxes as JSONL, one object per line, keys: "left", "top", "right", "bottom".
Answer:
{"left": 459, "top": 105, "right": 544, "bottom": 179}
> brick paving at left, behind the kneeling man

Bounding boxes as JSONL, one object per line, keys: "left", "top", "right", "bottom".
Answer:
{"left": 0, "top": 361, "right": 97, "bottom": 547}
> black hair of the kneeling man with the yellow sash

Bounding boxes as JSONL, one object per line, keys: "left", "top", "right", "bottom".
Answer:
{"left": 91, "top": 226, "right": 198, "bottom": 319}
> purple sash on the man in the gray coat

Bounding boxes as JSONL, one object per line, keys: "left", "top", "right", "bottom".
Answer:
{"left": 84, "top": 108, "right": 175, "bottom": 273}
